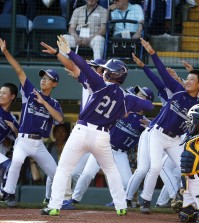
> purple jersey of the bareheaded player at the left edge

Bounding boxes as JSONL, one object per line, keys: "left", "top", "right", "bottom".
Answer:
{"left": 0, "top": 106, "right": 19, "bottom": 143}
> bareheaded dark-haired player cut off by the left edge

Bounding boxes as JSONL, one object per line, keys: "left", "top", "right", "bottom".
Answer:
{"left": 0, "top": 83, "right": 19, "bottom": 197}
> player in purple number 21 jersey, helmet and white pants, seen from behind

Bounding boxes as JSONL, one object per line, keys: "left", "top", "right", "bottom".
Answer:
{"left": 41, "top": 36, "right": 153, "bottom": 216}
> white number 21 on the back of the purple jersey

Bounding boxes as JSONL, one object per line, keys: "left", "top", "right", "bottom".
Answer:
{"left": 95, "top": 96, "right": 116, "bottom": 118}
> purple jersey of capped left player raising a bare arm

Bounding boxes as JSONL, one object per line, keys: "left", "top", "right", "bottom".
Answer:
{"left": 19, "top": 78, "right": 62, "bottom": 138}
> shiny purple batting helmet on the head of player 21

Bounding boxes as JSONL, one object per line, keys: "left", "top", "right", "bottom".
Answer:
{"left": 102, "top": 59, "right": 128, "bottom": 84}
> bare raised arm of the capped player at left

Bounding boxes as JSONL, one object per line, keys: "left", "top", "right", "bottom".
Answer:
{"left": 0, "top": 38, "right": 26, "bottom": 86}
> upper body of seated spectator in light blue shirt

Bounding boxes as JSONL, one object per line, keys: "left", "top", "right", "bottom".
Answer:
{"left": 109, "top": 0, "right": 144, "bottom": 39}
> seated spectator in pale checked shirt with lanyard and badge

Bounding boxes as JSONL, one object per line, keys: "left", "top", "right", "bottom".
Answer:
{"left": 64, "top": 0, "right": 108, "bottom": 59}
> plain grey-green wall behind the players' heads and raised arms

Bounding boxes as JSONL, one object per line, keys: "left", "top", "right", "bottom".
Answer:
{"left": 0, "top": 64, "right": 187, "bottom": 102}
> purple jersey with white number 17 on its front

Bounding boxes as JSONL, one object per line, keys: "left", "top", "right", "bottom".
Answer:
{"left": 110, "top": 113, "right": 145, "bottom": 151}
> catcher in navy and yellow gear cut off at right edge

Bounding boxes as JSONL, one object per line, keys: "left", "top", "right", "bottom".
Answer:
{"left": 179, "top": 104, "right": 199, "bottom": 223}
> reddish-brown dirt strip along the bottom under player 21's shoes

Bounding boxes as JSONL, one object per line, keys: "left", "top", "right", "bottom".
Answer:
{"left": 0, "top": 208, "right": 179, "bottom": 223}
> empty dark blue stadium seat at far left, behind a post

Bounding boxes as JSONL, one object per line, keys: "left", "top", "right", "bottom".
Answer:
{"left": 0, "top": 14, "right": 28, "bottom": 56}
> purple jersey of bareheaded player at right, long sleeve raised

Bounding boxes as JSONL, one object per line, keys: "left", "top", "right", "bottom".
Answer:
{"left": 152, "top": 54, "right": 199, "bottom": 135}
